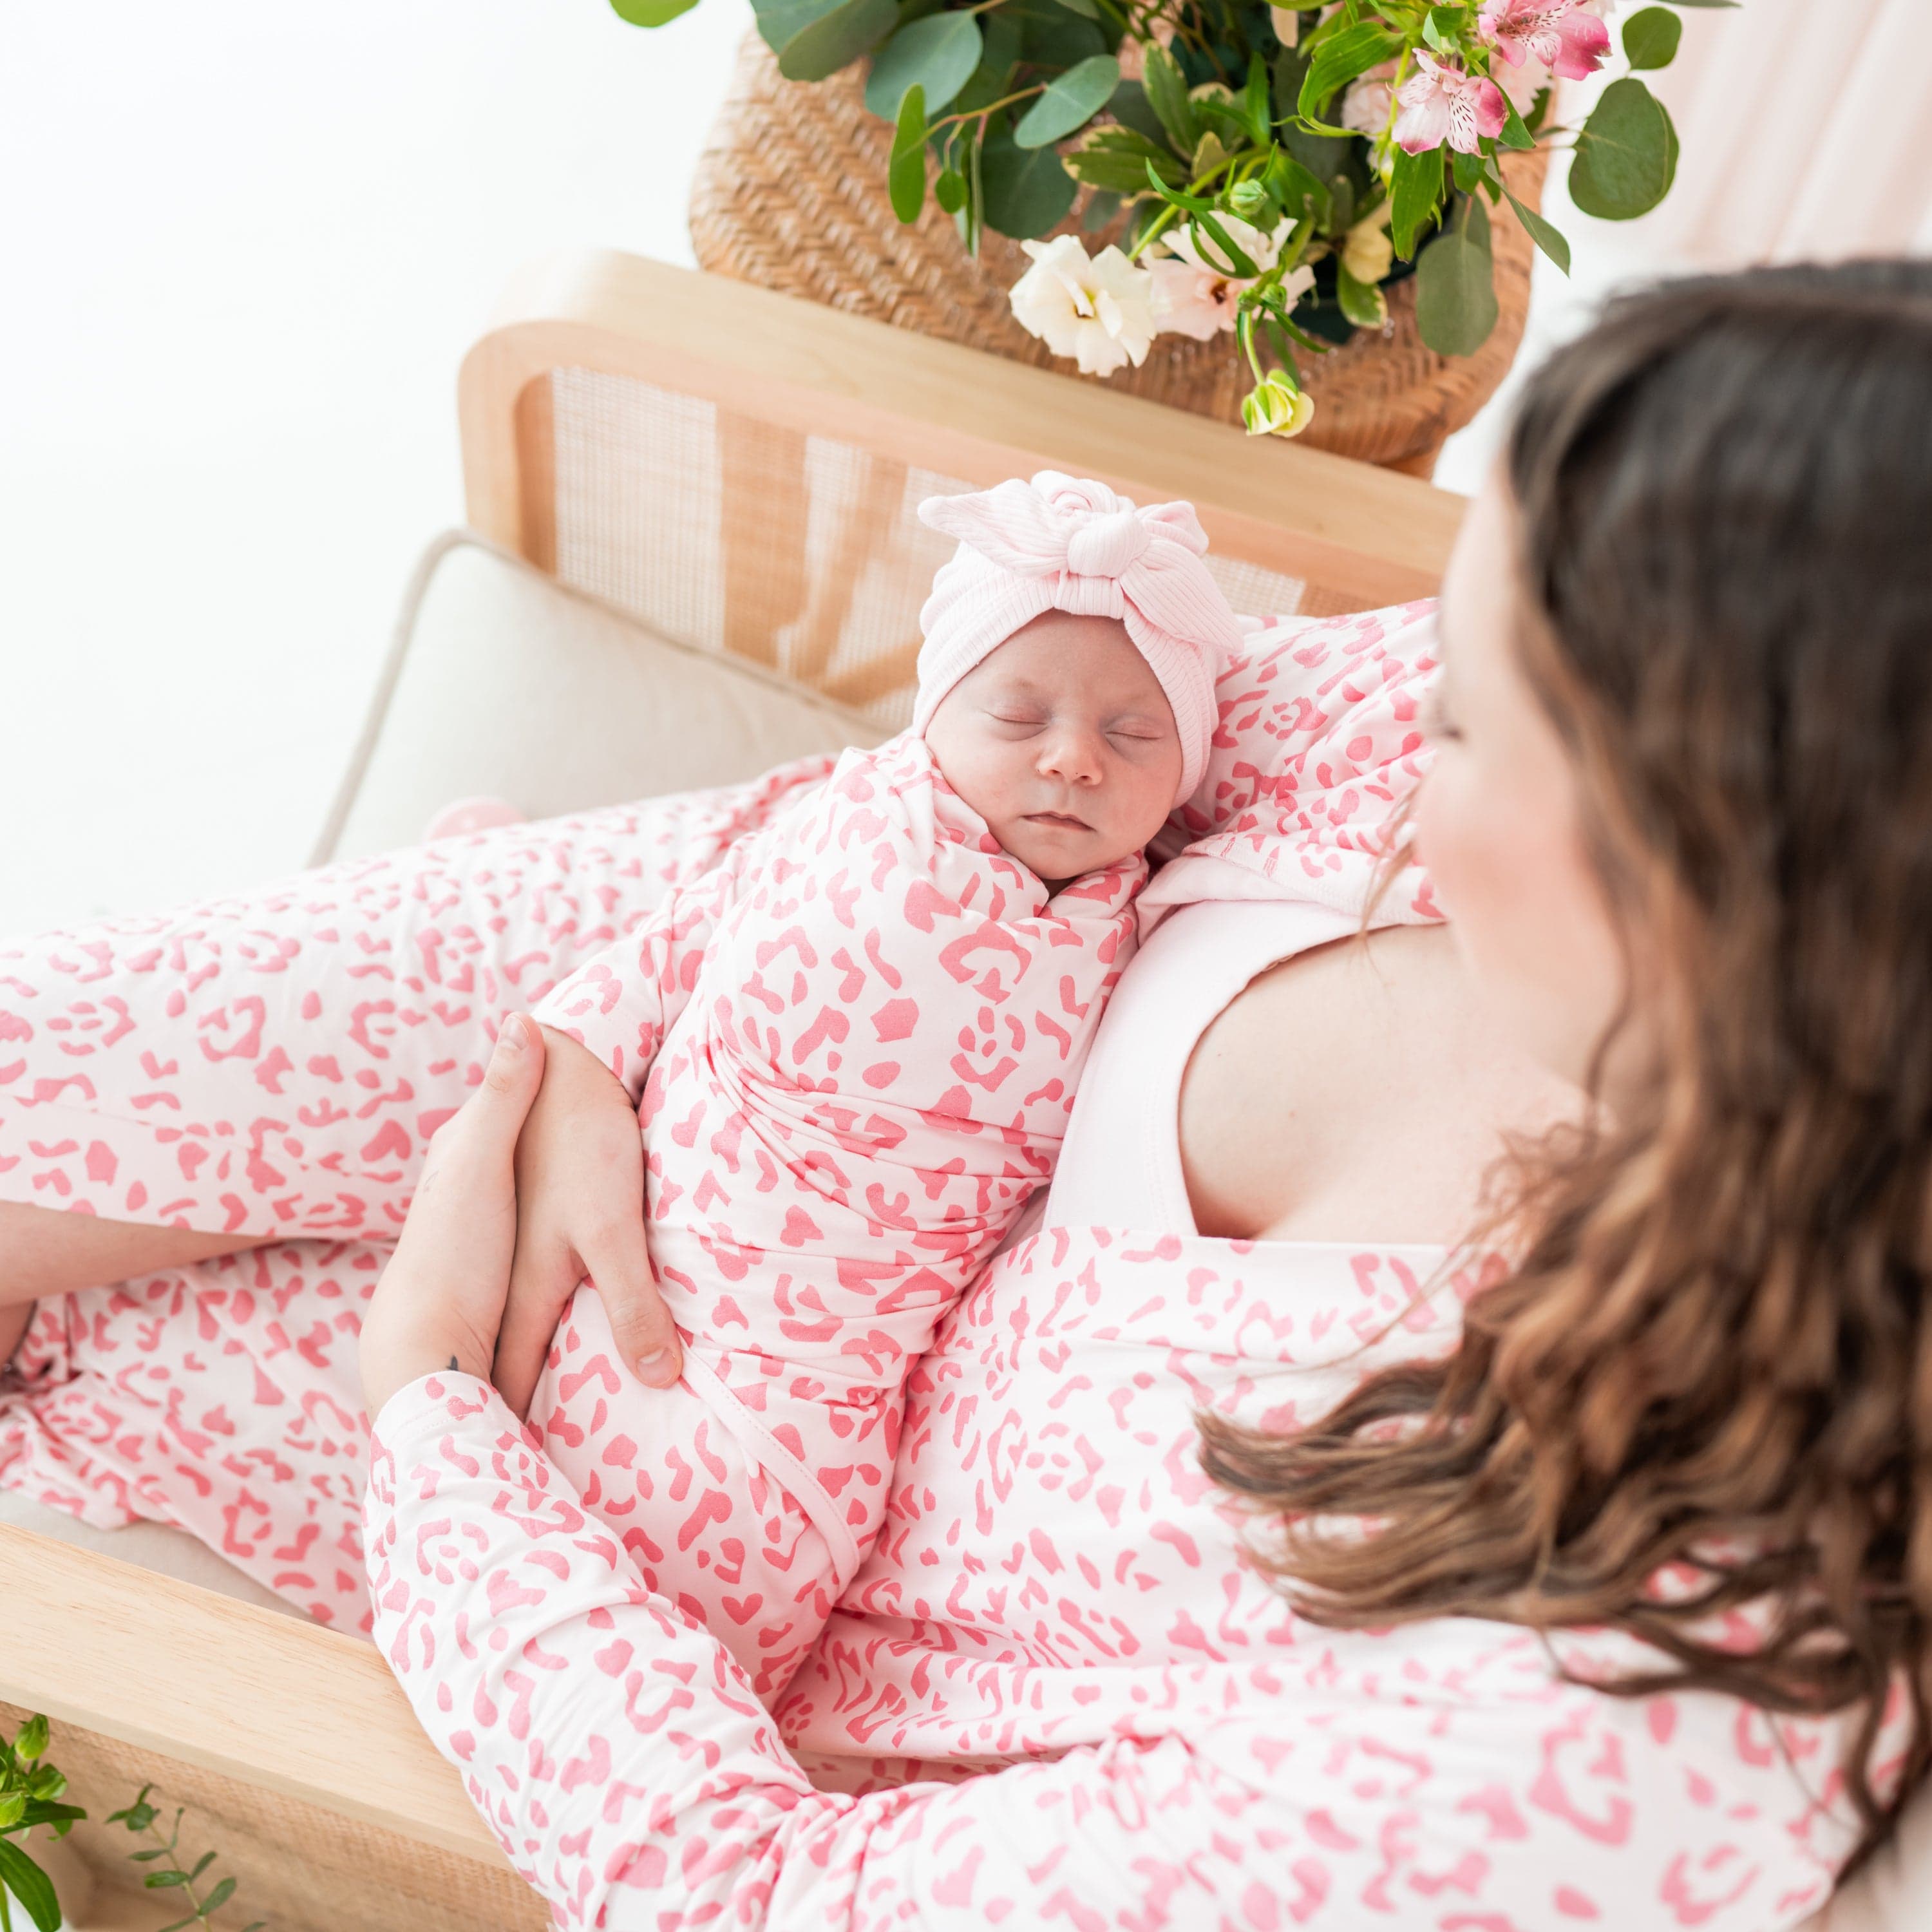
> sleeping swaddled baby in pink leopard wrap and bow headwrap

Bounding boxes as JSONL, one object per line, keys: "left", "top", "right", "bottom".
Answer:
{"left": 529, "top": 471, "right": 1238, "bottom": 1696}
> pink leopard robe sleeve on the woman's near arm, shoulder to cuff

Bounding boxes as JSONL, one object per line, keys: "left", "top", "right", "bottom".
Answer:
{"left": 367, "top": 1376, "right": 1841, "bottom": 1932}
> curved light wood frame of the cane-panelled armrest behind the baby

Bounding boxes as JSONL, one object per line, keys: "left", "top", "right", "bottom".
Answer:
{"left": 460, "top": 251, "right": 1463, "bottom": 607}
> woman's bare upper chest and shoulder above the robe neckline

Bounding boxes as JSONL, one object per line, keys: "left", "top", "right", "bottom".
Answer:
{"left": 1180, "top": 925, "right": 1578, "bottom": 1242}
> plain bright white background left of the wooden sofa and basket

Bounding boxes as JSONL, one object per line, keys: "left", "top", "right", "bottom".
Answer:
{"left": 0, "top": 0, "right": 1646, "bottom": 933}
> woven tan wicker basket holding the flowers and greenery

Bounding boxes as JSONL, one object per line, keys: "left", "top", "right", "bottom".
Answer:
{"left": 692, "top": 33, "right": 1548, "bottom": 475}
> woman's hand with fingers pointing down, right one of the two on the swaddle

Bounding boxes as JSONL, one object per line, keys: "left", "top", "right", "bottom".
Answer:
{"left": 493, "top": 1028, "right": 684, "bottom": 1418}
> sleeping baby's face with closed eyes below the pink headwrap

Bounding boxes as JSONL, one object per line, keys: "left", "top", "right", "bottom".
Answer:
{"left": 925, "top": 611, "right": 1182, "bottom": 887}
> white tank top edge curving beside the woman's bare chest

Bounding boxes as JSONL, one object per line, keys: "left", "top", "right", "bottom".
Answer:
{"left": 1051, "top": 900, "right": 1360, "bottom": 1235}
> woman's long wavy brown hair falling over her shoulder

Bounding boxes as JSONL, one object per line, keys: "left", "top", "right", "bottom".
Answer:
{"left": 1202, "top": 263, "right": 1932, "bottom": 1851}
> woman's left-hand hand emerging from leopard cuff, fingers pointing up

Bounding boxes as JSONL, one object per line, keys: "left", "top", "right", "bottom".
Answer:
{"left": 361, "top": 1012, "right": 543, "bottom": 1420}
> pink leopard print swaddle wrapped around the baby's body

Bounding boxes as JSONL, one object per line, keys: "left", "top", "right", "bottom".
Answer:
{"left": 531, "top": 734, "right": 1146, "bottom": 1696}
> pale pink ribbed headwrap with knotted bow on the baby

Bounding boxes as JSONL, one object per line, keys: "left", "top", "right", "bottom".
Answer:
{"left": 912, "top": 469, "right": 1240, "bottom": 804}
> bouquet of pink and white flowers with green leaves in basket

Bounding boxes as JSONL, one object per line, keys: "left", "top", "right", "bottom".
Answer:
{"left": 612, "top": 0, "right": 1735, "bottom": 435}
